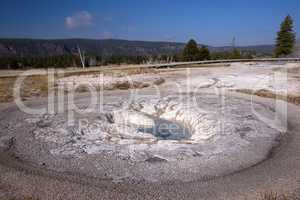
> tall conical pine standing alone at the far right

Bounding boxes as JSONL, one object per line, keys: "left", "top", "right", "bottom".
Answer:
{"left": 275, "top": 15, "right": 296, "bottom": 57}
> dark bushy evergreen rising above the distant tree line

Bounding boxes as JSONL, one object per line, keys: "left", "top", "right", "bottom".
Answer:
{"left": 182, "top": 39, "right": 201, "bottom": 61}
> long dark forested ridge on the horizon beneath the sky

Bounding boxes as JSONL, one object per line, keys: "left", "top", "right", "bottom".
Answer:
{"left": 0, "top": 39, "right": 274, "bottom": 57}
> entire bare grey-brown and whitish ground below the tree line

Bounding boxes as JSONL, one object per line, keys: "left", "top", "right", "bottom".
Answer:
{"left": 0, "top": 63, "right": 300, "bottom": 199}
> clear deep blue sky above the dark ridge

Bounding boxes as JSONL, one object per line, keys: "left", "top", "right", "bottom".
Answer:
{"left": 0, "top": 0, "right": 300, "bottom": 46}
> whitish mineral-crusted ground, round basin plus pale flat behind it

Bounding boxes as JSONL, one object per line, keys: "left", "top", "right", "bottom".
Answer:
{"left": 0, "top": 63, "right": 300, "bottom": 182}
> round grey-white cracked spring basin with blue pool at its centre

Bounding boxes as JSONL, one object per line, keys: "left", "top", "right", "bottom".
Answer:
{"left": 0, "top": 92, "right": 284, "bottom": 182}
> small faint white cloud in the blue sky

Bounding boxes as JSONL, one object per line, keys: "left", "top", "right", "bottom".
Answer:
{"left": 65, "top": 11, "right": 93, "bottom": 29}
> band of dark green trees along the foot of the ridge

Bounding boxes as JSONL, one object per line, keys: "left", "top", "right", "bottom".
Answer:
{"left": 0, "top": 44, "right": 255, "bottom": 69}
